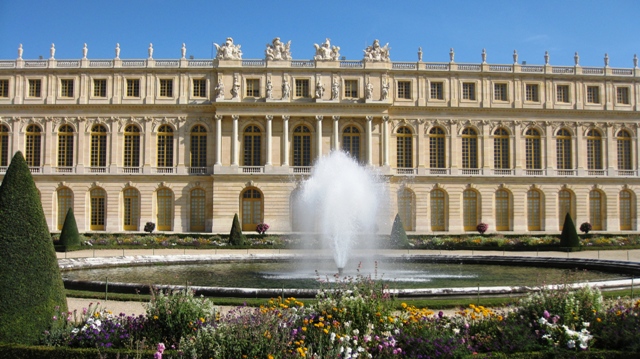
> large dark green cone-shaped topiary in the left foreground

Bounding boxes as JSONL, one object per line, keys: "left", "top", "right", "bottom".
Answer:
{"left": 0, "top": 152, "right": 67, "bottom": 344}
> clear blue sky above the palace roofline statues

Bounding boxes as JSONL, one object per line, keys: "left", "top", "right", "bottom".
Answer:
{"left": 0, "top": 0, "right": 640, "bottom": 68}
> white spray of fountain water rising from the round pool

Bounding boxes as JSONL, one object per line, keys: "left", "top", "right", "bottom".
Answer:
{"left": 295, "top": 151, "right": 386, "bottom": 273}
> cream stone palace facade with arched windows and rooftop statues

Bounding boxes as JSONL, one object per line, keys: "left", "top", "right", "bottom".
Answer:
{"left": 0, "top": 38, "right": 640, "bottom": 234}
